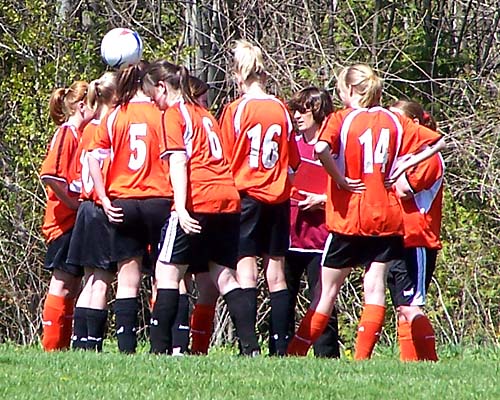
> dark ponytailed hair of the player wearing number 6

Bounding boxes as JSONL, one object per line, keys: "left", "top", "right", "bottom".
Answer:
{"left": 143, "top": 60, "right": 198, "bottom": 104}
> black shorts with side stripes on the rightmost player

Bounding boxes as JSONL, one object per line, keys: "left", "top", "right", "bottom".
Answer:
{"left": 387, "top": 247, "right": 438, "bottom": 307}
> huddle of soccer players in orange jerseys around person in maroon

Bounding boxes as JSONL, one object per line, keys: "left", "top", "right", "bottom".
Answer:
{"left": 40, "top": 40, "right": 444, "bottom": 361}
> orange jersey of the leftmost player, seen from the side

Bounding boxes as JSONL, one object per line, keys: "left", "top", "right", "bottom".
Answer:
{"left": 40, "top": 123, "right": 81, "bottom": 242}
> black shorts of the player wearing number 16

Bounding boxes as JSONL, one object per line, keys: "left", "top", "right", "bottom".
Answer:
{"left": 239, "top": 194, "right": 290, "bottom": 258}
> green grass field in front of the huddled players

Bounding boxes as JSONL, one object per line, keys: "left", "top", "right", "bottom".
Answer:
{"left": 0, "top": 345, "right": 500, "bottom": 400}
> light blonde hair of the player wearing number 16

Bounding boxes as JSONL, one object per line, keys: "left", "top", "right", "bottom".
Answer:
{"left": 233, "top": 39, "right": 267, "bottom": 82}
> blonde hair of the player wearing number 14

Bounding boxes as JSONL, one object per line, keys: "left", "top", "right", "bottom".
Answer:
{"left": 337, "top": 64, "right": 383, "bottom": 107}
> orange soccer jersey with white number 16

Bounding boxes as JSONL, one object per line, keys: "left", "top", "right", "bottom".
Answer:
{"left": 221, "top": 95, "right": 300, "bottom": 203}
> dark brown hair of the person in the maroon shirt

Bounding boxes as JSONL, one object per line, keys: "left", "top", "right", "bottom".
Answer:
{"left": 288, "top": 86, "right": 333, "bottom": 124}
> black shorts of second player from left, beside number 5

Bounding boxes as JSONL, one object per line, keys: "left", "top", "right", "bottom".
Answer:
{"left": 67, "top": 200, "right": 116, "bottom": 272}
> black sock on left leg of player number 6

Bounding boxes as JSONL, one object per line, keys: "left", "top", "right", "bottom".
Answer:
{"left": 149, "top": 289, "right": 179, "bottom": 354}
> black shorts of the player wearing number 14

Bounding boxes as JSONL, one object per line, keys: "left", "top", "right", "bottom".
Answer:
{"left": 321, "top": 233, "right": 404, "bottom": 269}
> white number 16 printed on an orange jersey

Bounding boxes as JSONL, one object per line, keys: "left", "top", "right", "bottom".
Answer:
{"left": 247, "top": 124, "right": 281, "bottom": 169}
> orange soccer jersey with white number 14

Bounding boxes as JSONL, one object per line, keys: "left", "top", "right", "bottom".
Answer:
{"left": 319, "top": 107, "right": 440, "bottom": 236}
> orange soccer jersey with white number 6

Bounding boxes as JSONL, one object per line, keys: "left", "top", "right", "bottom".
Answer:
{"left": 162, "top": 102, "right": 240, "bottom": 213}
